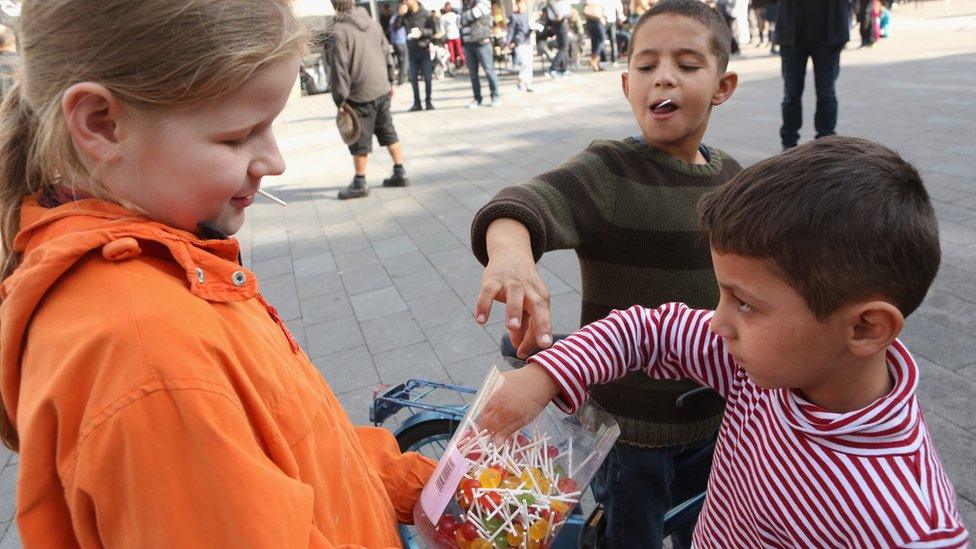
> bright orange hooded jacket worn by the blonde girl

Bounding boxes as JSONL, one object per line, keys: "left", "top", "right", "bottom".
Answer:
{"left": 0, "top": 199, "right": 434, "bottom": 548}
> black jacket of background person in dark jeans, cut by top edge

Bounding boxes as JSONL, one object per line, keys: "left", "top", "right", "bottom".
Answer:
{"left": 776, "top": 0, "right": 851, "bottom": 46}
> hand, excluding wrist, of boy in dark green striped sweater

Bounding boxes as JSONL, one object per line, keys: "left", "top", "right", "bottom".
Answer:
{"left": 475, "top": 253, "right": 552, "bottom": 359}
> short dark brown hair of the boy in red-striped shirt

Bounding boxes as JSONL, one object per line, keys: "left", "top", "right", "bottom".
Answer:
{"left": 698, "top": 137, "right": 941, "bottom": 320}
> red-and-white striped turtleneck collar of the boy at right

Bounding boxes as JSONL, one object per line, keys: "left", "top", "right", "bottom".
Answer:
{"left": 772, "top": 340, "right": 925, "bottom": 456}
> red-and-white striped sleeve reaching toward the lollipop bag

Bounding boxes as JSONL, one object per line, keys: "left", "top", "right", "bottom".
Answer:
{"left": 529, "top": 303, "right": 737, "bottom": 413}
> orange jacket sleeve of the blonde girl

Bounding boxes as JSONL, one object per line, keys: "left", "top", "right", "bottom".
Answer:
{"left": 65, "top": 385, "right": 366, "bottom": 548}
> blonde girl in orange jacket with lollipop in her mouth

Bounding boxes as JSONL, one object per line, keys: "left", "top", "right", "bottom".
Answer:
{"left": 0, "top": 0, "right": 433, "bottom": 548}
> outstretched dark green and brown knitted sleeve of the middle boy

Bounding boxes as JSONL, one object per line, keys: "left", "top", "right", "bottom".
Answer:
{"left": 471, "top": 145, "right": 614, "bottom": 265}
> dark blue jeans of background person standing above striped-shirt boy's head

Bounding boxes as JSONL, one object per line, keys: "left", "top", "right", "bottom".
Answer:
{"left": 779, "top": 45, "right": 844, "bottom": 147}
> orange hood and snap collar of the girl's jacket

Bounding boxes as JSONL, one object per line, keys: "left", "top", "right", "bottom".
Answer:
{"left": 0, "top": 198, "right": 257, "bottom": 426}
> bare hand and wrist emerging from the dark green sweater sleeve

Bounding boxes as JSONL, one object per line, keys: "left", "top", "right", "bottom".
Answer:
{"left": 475, "top": 218, "right": 552, "bottom": 359}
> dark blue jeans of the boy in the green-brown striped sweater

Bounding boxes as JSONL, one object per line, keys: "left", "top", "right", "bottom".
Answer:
{"left": 592, "top": 436, "right": 715, "bottom": 549}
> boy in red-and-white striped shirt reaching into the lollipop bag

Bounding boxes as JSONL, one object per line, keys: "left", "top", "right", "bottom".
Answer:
{"left": 485, "top": 137, "right": 969, "bottom": 548}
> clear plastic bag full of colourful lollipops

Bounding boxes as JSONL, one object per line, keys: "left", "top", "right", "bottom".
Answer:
{"left": 414, "top": 358, "right": 620, "bottom": 549}
